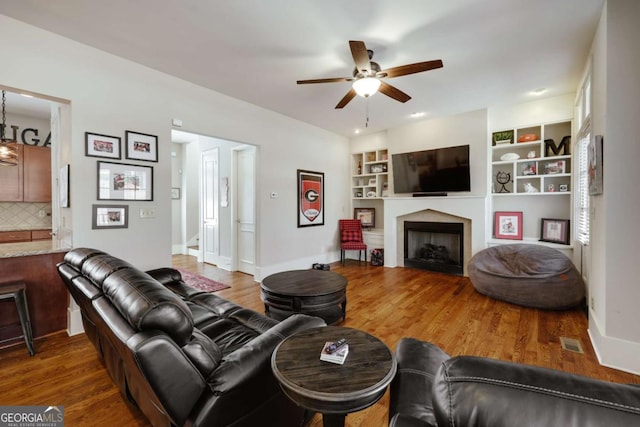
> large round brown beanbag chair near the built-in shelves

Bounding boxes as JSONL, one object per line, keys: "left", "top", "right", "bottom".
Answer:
{"left": 468, "top": 244, "right": 585, "bottom": 310}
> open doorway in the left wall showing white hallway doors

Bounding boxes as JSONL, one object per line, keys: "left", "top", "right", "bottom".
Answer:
{"left": 172, "top": 129, "right": 256, "bottom": 275}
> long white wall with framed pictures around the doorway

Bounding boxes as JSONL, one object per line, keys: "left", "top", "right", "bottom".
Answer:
{"left": 0, "top": 16, "right": 349, "bottom": 271}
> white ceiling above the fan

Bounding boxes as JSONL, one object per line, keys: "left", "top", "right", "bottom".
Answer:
{"left": 0, "top": 0, "right": 604, "bottom": 136}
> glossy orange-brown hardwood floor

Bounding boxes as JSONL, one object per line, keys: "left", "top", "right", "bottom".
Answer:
{"left": 0, "top": 255, "right": 640, "bottom": 427}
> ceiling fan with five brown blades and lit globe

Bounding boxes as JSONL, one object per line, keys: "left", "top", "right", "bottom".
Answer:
{"left": 297, "top": 40, "right": 442, "bottom": 108}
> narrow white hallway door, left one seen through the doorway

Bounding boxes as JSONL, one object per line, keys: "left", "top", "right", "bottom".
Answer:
{"left": 200, "top": 148, "right": 219, "bottom": 264}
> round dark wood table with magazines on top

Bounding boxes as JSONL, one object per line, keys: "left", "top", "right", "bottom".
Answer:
{"left": 271, "top": 326, "right": 397, "bottom": 427}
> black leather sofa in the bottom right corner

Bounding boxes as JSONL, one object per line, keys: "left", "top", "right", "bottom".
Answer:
{"left": 389, "top": 338, "right": 640, "bottom": 427}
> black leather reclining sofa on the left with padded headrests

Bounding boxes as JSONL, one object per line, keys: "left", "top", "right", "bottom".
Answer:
{"left": 57, "top": 248, "right": 324, "bottom": 427}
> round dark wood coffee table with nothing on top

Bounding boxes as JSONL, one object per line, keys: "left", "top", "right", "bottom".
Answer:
{"left": 260, "top": 270, "right": 347, "bottom": 324}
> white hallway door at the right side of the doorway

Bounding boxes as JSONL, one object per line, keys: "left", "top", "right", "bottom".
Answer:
{"left": 234, "top": 147, "right": 256, "bottom": 275}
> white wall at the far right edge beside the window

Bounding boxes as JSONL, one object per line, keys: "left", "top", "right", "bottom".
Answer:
{"left": 589, "top": 0, "right": 640, "bottom": 374}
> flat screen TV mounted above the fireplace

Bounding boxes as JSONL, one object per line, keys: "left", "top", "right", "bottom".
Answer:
{"left": 391, "top": 145, "right": 471, "bottom": 193}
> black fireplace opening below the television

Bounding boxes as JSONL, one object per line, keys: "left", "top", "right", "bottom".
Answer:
{"left": 404, "top": 221, "right": 464, "bottom": 276}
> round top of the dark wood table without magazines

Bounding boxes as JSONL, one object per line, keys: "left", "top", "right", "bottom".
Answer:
{"left": 260, "top": 270, "right": 347, "bottom": 297}
